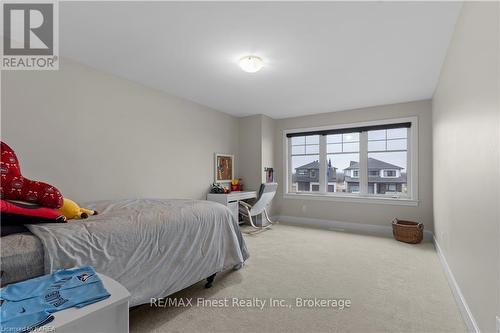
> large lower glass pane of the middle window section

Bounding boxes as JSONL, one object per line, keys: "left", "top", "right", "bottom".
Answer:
{"left": 326, "top": 152, "right": 359, "bottom": 193}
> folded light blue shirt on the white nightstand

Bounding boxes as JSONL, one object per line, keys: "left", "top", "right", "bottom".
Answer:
{"left": 0, "top": 266, "right": 110, "bottom": 332}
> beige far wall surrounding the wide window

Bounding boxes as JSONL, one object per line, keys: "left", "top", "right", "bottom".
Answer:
{"left": 274, "top": 101, "right": 433, "bottom": 230}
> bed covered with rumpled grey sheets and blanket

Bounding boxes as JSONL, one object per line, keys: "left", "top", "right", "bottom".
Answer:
{"left": 2, "top": 199, "right": 249, "bottom": 306}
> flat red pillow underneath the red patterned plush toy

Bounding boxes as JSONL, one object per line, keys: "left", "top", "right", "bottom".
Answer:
{"left": 0, "top": 199, "right": 67, "bottom": 225}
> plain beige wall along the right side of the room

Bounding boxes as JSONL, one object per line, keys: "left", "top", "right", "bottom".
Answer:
{"left": 433, "top": 2, "right": 500, "bottom": 332}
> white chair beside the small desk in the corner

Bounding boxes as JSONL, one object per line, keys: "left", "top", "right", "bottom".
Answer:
{"left": 240, "top": 183, "right": 278, "bottom": 233}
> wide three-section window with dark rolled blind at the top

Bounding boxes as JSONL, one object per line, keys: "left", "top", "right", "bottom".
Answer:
{"left": 285, "top": 118, "right": 418, "bottom": 204}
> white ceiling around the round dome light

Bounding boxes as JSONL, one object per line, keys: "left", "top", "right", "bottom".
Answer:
{"left": 60, "top": 2, "right": 461, "bottom": 118}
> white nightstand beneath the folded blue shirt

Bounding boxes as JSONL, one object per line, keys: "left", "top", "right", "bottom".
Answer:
{"left": 40, "top": 274, "right": 130, "bottom": 333}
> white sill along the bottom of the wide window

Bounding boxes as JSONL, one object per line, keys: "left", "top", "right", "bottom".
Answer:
{"left": 283, "top": 193, "right": 419, "bottom": 207}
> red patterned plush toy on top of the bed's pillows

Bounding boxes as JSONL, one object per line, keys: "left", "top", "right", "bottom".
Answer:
{"left": 0, "top": 141, "right": 63, "bottom": 208}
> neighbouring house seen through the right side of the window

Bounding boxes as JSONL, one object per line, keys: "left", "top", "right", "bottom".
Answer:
{"left": 344, "top": 158, "right": 406, "bottom": 194}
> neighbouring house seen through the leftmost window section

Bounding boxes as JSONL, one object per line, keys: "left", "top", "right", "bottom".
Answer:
{"left": 292, "top": 160, "right": 337, "bottom": 192}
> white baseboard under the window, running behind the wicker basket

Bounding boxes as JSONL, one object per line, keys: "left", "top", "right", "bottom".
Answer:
{"left": 273, "top": 215, "right": 433, "bottom": 240}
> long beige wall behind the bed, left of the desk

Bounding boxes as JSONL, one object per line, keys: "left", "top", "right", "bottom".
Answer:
{"left": 1, "top": 59, "right": 238, "bottom": 201}
